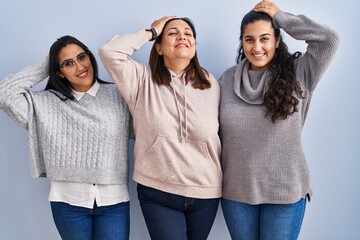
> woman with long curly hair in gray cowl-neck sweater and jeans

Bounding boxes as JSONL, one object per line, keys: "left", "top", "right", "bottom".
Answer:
{"left": 220, "top": 0, "right": 339, "bottom": 240}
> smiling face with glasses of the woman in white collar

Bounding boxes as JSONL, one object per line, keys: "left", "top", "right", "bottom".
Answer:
{"left": 57, "top": 44, "right": 94, "bottom": 92}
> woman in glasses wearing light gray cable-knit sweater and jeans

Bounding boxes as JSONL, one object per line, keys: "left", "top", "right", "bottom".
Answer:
{"left": 0, "top": 36, "right": 129, "bottom": 240}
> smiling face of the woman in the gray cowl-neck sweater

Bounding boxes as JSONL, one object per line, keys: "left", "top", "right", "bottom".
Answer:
{"left": 242, "top": 20, "right": 280, "bottom": 70}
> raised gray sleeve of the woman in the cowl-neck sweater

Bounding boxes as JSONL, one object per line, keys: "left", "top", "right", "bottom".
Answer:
{"left": 273, "top": 11, "right": 340, "bottom": 91}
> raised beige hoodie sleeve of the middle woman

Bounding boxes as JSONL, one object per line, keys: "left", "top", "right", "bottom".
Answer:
{"left": 99, "top": 29, "right": 151, "bottom": 111}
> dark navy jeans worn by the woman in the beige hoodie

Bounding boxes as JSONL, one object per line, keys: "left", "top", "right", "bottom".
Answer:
{"left": 137, "top": 184, "right": 220, "bottom": 240}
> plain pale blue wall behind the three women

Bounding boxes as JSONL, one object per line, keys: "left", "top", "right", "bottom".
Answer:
{"left": 0, "top": 0, "right": 360, "bottom": 240}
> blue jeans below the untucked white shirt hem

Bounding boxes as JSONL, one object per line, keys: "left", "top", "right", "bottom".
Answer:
{"left": 50, "top": 202, "right": 130, "bottom": 240}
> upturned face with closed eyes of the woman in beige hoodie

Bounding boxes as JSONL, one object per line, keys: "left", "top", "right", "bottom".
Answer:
{"left": 156, "top": 19, "right": 196, "bottom": 66}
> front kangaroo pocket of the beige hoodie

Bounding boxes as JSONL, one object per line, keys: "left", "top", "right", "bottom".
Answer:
{"left": 137, "top": 136, "right": 222, "bottom": 186}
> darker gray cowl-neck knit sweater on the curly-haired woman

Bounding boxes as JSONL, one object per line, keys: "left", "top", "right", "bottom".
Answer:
{"left": 220, "top": 11, "right": 339, "bottom": 204}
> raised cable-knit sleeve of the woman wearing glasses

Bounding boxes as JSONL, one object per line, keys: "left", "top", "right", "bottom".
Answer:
{"left": 0, "top": 57, "right": 49, "bottom": 129}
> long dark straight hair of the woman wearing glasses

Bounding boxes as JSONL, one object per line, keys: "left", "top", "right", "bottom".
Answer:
{"left": 45, "top": 35, "right": 106, "bottom": 100}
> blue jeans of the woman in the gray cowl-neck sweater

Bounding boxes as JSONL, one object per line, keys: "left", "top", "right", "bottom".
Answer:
{"left": 221, "top": 198, "right": 306, "bottom": 240}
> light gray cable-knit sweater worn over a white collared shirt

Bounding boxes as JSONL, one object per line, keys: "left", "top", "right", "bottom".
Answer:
{"left": 0, "top": 57, "right": 129, "bottom": 184}
